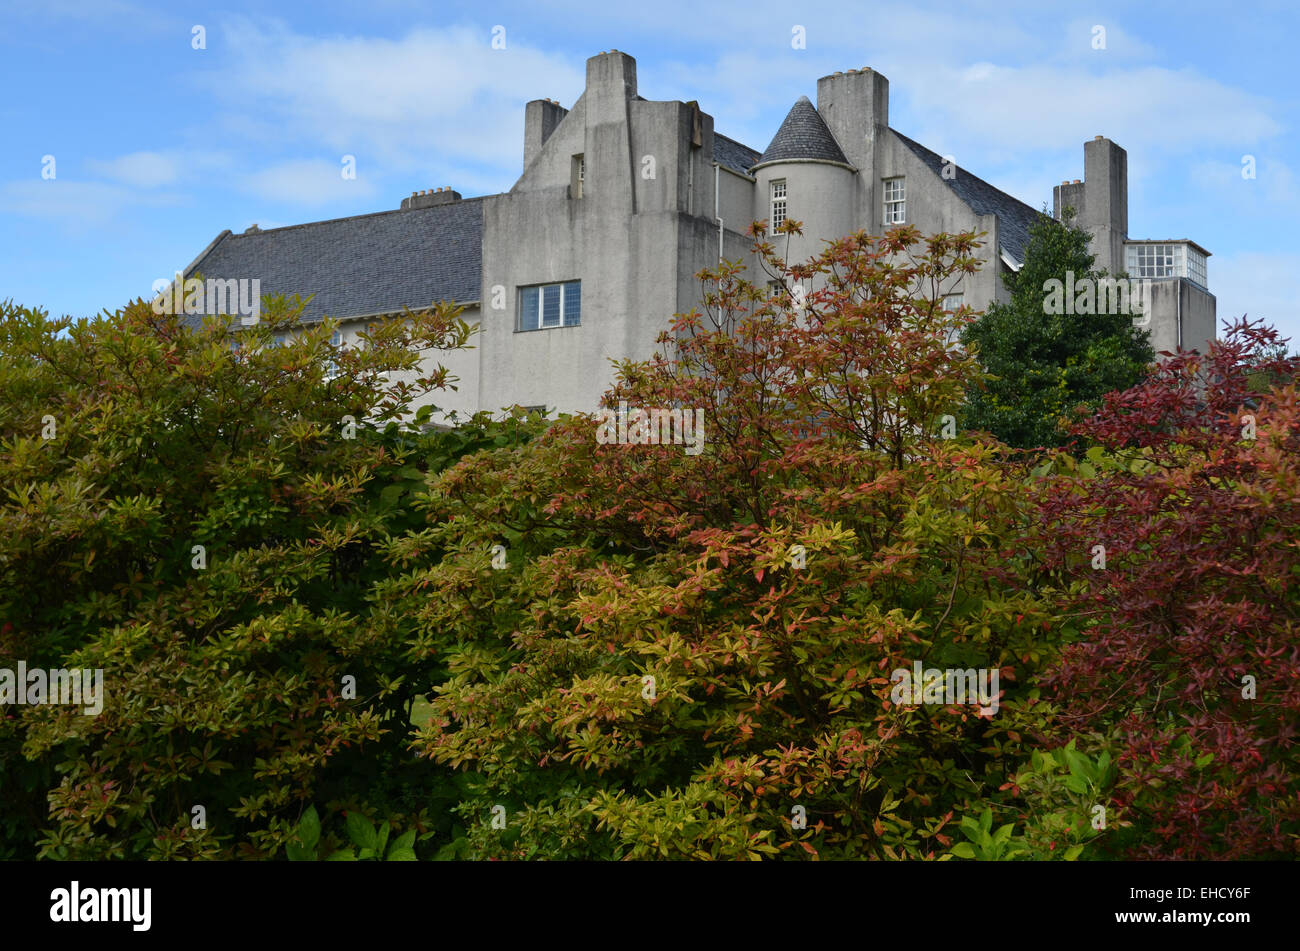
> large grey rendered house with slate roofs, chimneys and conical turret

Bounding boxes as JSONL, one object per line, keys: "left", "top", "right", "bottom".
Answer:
{"left": 178, "top": 51, "right": 1216, "bottom": 413}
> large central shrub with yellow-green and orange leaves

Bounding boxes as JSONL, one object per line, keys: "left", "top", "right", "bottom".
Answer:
{"left": 403, "top": 225, "right": 1066, "bottom": 859}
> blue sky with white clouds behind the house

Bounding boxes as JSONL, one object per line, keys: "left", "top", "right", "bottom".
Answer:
{"left": 0, "top": 0, "right": 1300, "bottom": 347}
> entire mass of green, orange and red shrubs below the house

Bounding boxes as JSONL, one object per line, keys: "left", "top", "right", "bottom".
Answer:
{"left": 0, "top": 221, "right": 1300, "bottom": 860}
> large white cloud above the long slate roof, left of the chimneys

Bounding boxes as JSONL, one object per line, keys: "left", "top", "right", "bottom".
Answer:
{"left": 202, "top": 18, "right": 584, "bottom": 185}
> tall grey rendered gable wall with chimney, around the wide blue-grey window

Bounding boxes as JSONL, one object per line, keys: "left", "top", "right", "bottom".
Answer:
{"left": 478, "top": 52, "right": 748, "bottom": 412}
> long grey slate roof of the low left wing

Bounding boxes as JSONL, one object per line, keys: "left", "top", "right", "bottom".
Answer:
{"left": 186, "top": 199, "right": 482, "bottom": 322}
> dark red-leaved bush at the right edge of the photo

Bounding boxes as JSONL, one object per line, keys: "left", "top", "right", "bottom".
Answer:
{"left": 1041, "top": 318, "right": 1300, "bottom": 859}
